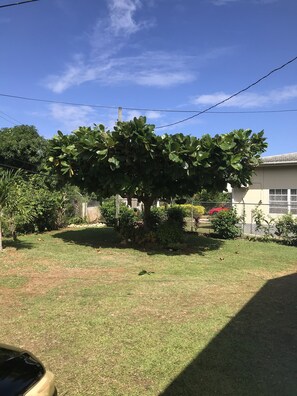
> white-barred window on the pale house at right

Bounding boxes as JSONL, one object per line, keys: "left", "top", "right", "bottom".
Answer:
{"left": 269, "top": 188, "right": 297, "bottom": 214}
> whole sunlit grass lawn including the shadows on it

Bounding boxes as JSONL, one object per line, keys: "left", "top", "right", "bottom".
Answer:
{"left": 0, "top": 228, "right": 297, "bottom": 396}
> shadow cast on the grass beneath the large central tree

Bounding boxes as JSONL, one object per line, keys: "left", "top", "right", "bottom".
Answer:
{"left": 53, "top": 227, "right": 224, "bottom": 256}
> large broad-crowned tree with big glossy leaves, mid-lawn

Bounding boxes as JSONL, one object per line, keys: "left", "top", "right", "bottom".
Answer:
{"left": 49, "top": 117, "right": 267, "bottom": 227}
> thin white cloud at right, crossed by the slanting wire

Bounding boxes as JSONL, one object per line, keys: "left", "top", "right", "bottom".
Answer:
{"left": 192, "top": 85, "right": 297, "bottom": 108}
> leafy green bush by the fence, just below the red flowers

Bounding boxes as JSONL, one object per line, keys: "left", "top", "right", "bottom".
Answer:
{"left": 210, "top": 209, "right": 241, "bottom": 239}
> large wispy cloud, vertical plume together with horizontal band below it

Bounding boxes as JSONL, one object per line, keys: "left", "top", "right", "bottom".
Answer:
{"left": 43, "top": 0, "right": 230, "bottom": 93}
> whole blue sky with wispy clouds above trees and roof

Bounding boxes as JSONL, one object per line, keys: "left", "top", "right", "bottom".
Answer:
{"left": 0, "top": 0, "right": 297, "bottom": 155}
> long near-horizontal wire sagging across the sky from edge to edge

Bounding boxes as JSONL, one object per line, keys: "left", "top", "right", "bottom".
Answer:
{"left": 0, "top": 93, "right": 297, "bottom": 118}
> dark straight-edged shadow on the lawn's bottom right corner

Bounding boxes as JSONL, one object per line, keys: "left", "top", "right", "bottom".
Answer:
{"left": 161, "top": 274, "right": 297, "bottom": 396}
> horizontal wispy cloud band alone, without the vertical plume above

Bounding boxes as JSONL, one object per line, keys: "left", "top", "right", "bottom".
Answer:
{"left": 45, "top": 51, "right": 195, "bottom": 93}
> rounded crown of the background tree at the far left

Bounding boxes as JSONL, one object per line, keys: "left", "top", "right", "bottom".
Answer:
{"left": 0, "top": 125, "right": 47, "bottom": 171}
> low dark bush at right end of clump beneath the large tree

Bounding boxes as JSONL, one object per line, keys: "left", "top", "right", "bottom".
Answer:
{"left": 156, "top": 219, "right": 184, "bottom": 248}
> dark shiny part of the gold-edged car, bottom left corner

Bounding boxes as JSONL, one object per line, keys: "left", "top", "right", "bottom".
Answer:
{"left": 0, "top": 345, "right": 45, "bottom": 396}
